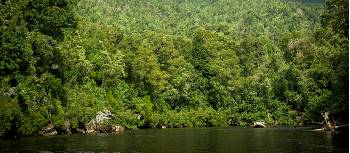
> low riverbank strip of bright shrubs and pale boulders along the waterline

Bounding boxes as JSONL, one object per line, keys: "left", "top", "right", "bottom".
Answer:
{"left": 3, "top": 107, "right": 314, "bottom": 137}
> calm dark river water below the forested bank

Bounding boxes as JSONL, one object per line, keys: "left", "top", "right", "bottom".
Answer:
{"left": 0, "top": 127, "right": 349, "bottom": 153}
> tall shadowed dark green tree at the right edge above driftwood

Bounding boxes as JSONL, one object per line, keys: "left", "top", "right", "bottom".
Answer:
{"left": 307, "top": 0, "right": 349, "bottom": 122}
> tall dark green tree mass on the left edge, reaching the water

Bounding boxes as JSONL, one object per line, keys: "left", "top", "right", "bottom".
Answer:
{"left": 0, "top": 0, "right": 76, "bottom": 135}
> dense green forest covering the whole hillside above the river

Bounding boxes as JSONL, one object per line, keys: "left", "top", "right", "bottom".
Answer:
{"left": 0, "top": 0, "right": 349, "bottom": 136}
